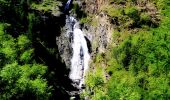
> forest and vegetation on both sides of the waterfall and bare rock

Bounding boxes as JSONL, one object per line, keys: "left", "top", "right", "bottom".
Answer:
{"left": 0, "top": 0, "right": 170, "bottom": 100}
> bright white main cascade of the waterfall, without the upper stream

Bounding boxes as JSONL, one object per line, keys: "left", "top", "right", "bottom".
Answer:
{"left": 69, "top": 17, "right": 90, "bottom": 88}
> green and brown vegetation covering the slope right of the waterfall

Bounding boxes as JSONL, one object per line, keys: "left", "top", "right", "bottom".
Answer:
{"left": 82, "top": 0, "right": 170, "bottom": 100}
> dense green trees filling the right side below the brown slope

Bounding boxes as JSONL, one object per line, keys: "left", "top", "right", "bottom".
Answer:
{"left": 108, "top": 0, "right": 170, "bottom": 100}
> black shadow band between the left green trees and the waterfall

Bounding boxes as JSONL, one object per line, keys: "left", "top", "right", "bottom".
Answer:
{"left": 32, "top": 12, "right": 76, "bottom": 100}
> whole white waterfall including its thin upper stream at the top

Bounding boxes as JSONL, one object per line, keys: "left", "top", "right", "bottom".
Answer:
{"left": 64, "top": 0, "right": 90, "bottom": 88}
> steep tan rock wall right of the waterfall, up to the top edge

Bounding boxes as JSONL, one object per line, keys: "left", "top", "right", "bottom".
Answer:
{"left": 83, "top": 0, "right": 113, "bottom": 54}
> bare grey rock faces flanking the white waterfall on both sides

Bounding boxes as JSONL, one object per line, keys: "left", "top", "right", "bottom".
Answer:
{"left": 56, "top": 0, "right": 112, "bottom": 68}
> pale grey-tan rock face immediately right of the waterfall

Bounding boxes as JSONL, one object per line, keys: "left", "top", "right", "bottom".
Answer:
{"left": 82, "top": 17, "right": 111, "bottom": 56}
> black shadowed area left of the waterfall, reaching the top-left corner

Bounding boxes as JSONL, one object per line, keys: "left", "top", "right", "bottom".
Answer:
{"left": 0, "top": 0, "right": 77, "bottom": 100}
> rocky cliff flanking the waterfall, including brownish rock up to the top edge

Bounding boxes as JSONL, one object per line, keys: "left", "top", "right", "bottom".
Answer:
{"left": 56, "top": 0, "right": 112, "bottom": 68}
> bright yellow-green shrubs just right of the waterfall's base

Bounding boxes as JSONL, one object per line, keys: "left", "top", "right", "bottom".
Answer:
{"left": 82, "top": 54, "right": 107, "bottom": 100}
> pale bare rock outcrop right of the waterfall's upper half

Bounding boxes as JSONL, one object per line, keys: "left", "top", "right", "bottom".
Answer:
{"left": 83, "top": 13, "right": 112, "bottom": 54}
